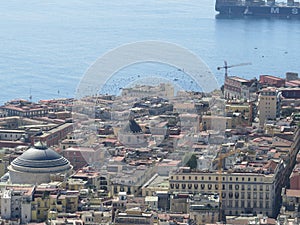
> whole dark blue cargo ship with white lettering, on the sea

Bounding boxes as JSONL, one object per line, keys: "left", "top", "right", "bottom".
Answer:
{"left": 215, "top": 0, "right": 300, "bottom": 18}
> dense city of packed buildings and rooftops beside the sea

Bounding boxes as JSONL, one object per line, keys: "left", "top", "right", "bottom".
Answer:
{"left": 0, "top": 73, "right": 300, "bottom": 225}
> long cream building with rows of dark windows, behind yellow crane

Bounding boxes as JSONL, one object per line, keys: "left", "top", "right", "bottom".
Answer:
{"left": 169, "top": 164, "right": 281, "bottom": 216}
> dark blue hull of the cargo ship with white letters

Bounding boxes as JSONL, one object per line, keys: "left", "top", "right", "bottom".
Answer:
{"left": 215, "top": 1, "right": 300, "bottom": 18}
